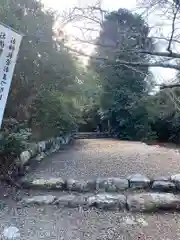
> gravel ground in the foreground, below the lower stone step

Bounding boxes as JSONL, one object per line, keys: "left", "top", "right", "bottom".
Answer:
{"left": 0, "top": 195, "right": 180, "bottom": 240}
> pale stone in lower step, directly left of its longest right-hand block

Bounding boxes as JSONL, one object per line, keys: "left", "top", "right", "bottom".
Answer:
{"left": 88, "top": 193, "right": 126, "bottom": 209}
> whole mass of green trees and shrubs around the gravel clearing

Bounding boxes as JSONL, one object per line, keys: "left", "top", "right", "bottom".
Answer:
{"left": 0, "top": 0, "right": 180, "bottom": 160}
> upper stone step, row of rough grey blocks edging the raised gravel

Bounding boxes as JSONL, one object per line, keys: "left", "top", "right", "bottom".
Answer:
{"left": 20, "top": 174, "right": 180, "bottom": 193}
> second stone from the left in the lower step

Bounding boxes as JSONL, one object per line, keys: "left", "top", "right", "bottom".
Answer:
{"left": 54, "top": 194, "right": 87, "bottom": 208}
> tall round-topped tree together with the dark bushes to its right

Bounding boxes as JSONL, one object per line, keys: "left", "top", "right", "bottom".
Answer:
{"left": 84, "top": 9, "right": 180, "bottom": 143}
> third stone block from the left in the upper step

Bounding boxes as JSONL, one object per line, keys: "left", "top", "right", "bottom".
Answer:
{"left": 96, "top": 178, "right": 129, "bottom": 192}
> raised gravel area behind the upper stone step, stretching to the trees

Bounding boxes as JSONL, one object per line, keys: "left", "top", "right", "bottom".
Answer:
{"left": 27, "top": 139, "right": 180, "bottom": 179}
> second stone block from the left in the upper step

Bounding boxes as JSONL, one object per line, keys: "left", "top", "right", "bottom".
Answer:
{"left": 66, "top": 179, "right": 96, "bottom": 192}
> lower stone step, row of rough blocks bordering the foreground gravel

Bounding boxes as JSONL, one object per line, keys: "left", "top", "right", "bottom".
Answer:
{"left": 19, "top": 193, "right": 180, "bottom": 212}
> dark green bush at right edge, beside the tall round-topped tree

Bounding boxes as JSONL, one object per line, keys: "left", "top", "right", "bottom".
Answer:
{"left": 146, "top": 88, "right": 180, "bottom": 143}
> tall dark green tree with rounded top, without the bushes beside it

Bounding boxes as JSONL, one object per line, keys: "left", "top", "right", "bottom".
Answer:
{"left": 90, "top": 9, "right": 153, "bottom": 140}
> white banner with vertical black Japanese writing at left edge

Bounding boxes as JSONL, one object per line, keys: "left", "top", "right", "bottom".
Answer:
{"left": 0, "top": 24, "right": 22, "bottom": 127}
